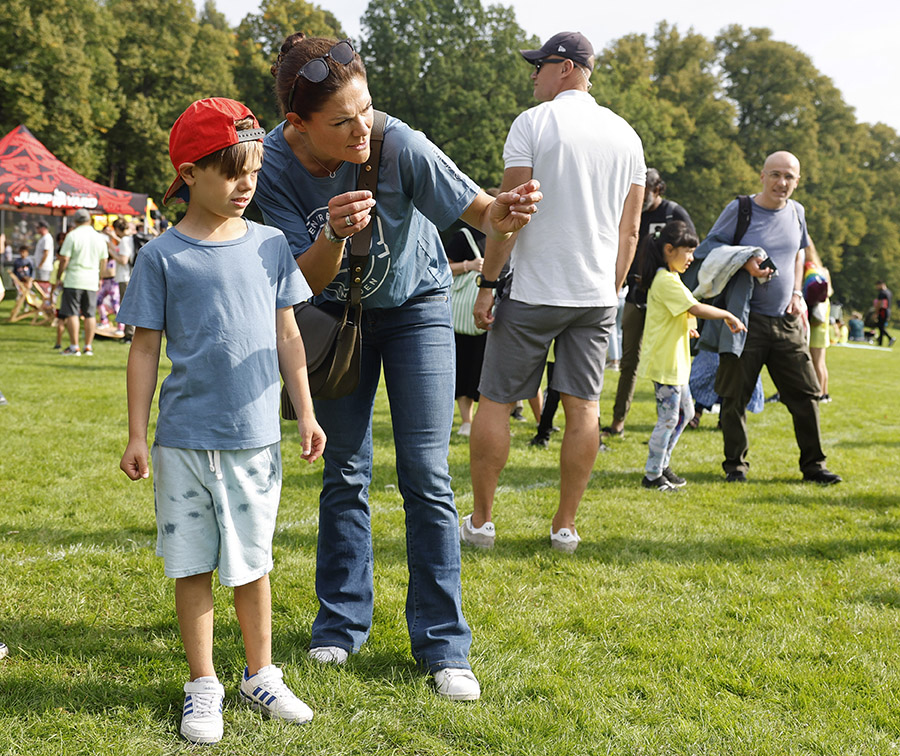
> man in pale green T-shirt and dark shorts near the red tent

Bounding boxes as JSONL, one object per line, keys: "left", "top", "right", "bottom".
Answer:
{"left": 56, "top": 208, "right": 109, "bottom": 357}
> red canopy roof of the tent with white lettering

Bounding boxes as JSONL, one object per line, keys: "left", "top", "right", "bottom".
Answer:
{"left": 0, "top": 126, "right": 147, "bottom": 215}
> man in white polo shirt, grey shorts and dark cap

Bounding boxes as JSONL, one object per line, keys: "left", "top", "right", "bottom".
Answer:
{"left": 460, "top": 32, "right": 646, "bottom": 552}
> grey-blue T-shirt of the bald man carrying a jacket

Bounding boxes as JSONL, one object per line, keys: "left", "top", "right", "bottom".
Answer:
{"left": 694, "top": 199, "right": 809, "bottom": 318}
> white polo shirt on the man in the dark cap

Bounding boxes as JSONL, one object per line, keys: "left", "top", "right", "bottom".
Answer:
{"left": 503, "top": 90, "right": 647, "bottom": 307}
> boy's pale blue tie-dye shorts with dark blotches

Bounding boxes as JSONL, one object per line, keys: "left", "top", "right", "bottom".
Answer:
{"left": 150, "top": 443, "right": 281, "bottom": 586}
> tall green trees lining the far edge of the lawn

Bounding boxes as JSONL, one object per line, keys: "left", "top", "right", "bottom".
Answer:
{"left": 0, "top": 0, "right": 900, "bottom": 308}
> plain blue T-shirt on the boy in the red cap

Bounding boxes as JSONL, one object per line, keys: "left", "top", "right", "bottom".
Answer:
{"left": 117, "top": 221, "right": 312, "bottom": 451}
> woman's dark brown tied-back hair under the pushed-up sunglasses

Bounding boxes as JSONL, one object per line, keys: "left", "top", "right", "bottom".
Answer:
{"left": 269, "top": 32, "right": 366, "bottom": 118}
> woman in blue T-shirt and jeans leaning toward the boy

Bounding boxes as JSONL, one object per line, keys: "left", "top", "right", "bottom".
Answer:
{"left": 256, "top": 34, "right": 541, "bottom": 700}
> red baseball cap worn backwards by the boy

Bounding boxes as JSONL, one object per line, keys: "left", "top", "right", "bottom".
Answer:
{"left": 163, "top": 97, "right": 266, "bottom": 204}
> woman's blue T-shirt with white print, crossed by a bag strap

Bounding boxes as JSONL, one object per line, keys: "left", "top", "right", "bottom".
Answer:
{"left": 256, "top": 116, "right": 478, "bottom": 309}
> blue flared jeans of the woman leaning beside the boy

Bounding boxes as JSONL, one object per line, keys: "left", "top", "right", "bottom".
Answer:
{"left": 310, "top": 292, "right": 472, "bottom": 672}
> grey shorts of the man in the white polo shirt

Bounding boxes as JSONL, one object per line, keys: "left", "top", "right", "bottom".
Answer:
{"left": 478, "top": 297, "right": 616, "bottom": 404}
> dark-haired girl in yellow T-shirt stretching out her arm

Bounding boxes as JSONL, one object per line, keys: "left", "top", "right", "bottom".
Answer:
{"left": 638, "top": 221, "right": 747, "bottom": 491}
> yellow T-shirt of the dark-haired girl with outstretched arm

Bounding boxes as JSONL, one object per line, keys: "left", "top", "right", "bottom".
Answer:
{"left": 638, "top": 268, "right": 698, "bottom": 386}
